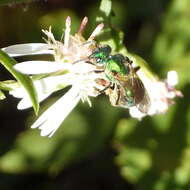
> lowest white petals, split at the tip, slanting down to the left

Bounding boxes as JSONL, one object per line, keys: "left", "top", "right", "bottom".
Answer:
{"left": 31, "top": 87, "right": 80, "bottom": 137}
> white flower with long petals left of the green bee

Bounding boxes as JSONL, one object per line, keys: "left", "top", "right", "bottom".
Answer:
{"left": 3, "top": 17, "right": 104, "bottom": 137}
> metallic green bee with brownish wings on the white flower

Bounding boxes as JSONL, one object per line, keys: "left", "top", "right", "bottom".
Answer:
{"left": 89, "top": 45, "right": 150, "bottom": 113}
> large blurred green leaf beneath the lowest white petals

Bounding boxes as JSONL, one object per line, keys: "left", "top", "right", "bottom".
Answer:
{"left": 0, "top": 98, "right": 120, "bottom": 176}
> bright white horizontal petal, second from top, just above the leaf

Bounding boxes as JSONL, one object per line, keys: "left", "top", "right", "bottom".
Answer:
{"left": 14, "top": 61, "right": 64, "bottom": 75}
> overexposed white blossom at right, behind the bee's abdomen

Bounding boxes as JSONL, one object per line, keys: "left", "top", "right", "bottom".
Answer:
{"left": 129, "top": 69, "right": 183, "bottom": 119}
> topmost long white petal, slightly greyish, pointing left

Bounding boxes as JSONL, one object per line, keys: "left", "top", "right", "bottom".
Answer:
{"left": 2, "top": 43, "right": 53, "bottom": 57}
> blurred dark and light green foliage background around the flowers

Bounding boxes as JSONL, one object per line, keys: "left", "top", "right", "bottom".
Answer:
{"left": 0, "top": 0, "right": 190, "bottom": 190}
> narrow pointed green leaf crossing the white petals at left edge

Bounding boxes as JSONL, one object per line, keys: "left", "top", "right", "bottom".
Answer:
{"left": 0, "top": 50, "right": 39, "bottom": 115}
